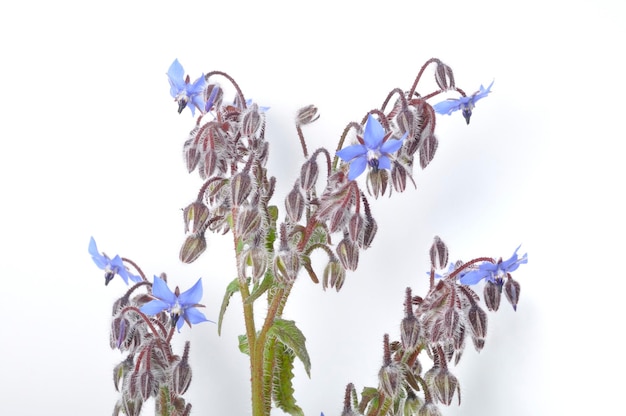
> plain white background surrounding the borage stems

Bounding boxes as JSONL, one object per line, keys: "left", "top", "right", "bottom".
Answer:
{"left": 0, "top": 1, "right": 626, "bottom": 416}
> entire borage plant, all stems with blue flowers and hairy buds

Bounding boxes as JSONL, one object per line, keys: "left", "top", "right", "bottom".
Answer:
{"left": 89, "top": 59, "right": 527, "bottom": 416}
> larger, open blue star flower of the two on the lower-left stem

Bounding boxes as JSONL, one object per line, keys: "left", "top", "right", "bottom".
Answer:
{"left": 140, "top": 276, "right": 213, "bottom": 332}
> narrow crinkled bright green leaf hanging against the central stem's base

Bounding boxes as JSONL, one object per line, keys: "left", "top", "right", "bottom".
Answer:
{"left": 272, "top": 343, "right": 304, "bottom": 416}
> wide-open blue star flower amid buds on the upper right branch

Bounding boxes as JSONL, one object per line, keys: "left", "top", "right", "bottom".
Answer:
{"left": 337, "top": 114, "right": 407, "bottom": 180}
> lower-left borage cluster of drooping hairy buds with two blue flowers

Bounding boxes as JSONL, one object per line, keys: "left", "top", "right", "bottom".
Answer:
{"left": 89, "top": 237, "right": 211, "bottom": 416}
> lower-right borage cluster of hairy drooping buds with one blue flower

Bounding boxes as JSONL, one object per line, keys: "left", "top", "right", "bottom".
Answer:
{"left": 336, "top": 237, "right": 527, "bottom": 415}
